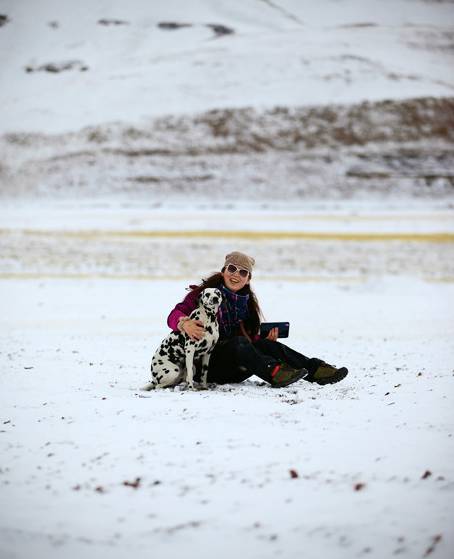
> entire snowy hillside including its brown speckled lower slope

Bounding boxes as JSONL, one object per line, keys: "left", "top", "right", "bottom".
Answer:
{"left": 0, "top": 0, "right": 454, "bottom": 205}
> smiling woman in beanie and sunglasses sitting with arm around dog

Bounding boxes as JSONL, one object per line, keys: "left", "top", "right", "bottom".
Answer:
{"left": 167, "top": 252, "right": 348, "bottom": 388}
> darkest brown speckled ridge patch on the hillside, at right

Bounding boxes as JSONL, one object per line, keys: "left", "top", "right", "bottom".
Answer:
{"left": 188, "top": 97, "right": 454, "bottom": 152}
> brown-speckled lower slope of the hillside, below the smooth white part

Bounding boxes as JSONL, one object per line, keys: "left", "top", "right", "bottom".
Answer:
{"left": 0, "top": 98, "right": 454, "bottom": 204}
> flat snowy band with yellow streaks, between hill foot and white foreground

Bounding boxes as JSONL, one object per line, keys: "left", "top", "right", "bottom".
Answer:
{"left": 0, "top": 203, "right": 454, "bottom": 282}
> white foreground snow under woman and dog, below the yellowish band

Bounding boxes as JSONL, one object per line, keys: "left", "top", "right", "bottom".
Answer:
{"left": 0, "top": 278, "right": 454, "bottom": 559}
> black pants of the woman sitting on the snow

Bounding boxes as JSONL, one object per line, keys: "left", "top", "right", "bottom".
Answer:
{"left": 208, "top": 336, "right": 321, "bottom": 384}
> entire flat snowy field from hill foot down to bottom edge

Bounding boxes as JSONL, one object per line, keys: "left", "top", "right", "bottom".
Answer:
{"left": 0, "top": 208, "right": 454, "bottom": 559}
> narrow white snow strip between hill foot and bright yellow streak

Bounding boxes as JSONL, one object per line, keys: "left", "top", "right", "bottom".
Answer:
{"left": 0, "top": 205, "right": 454, "bottom": 233}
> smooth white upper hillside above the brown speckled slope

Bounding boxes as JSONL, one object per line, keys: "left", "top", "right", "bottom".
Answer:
{"left": 0, "top": 0, "right": 454, "bottom": 133}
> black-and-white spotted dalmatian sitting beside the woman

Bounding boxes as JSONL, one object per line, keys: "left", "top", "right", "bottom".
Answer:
{"left": 144, "top": 287, "right": 222, "bottom": 390}
